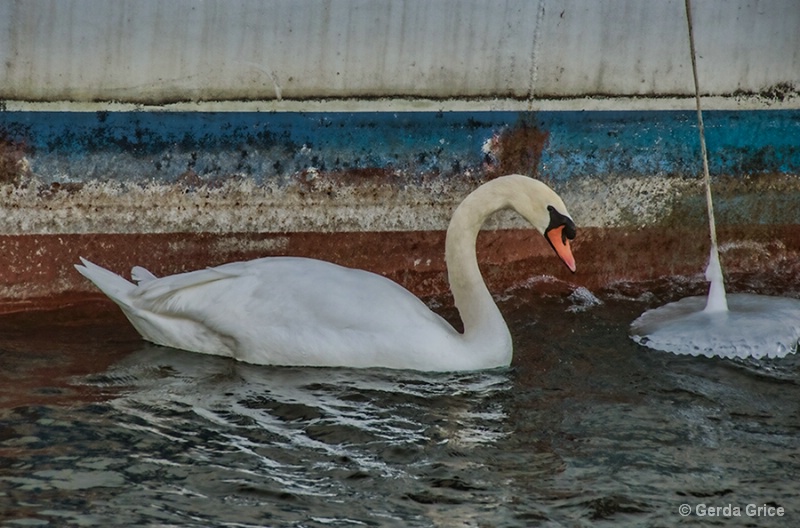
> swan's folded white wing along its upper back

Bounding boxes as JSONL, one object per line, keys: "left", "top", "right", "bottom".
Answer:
{"left": 135, "top": 257, "right": 450, "bottom": 330}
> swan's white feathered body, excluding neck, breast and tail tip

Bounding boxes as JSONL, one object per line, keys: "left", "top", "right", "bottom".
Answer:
{"left": 123, "top": 257, "right": 468, "bottom": 370}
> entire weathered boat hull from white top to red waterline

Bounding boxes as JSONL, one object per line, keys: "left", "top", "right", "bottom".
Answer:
{"left": 0, "top": 0, "right": 800, "bottom": 311}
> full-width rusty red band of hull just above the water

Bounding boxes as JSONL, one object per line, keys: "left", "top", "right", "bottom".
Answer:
{"left": 0, "top": 225, "right": 800, "bottom": 313}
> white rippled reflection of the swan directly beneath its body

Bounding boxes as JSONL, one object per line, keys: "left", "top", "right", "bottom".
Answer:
{"left": 95, "top": 348, "right": 509, "bottom": 523}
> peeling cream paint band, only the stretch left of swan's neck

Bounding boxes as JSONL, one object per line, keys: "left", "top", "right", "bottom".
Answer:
{"left": 0, "top": 180, "right": 476, "bottom": 234}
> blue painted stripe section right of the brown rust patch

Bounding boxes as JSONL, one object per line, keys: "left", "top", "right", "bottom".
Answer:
{"left": 537, "top": 110, "right": 800, "bottom": 179}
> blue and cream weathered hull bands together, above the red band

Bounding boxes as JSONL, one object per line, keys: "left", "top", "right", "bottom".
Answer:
{"left": 0, "top": 110, "right": 800, "bottom": 234}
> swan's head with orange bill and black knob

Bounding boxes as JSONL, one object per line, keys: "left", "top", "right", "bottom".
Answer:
{"left": 511, "top": 176, "right": 577, "bottom": 273}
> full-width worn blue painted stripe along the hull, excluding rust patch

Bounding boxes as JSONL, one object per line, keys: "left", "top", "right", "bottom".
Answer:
{"left": 0, "top": 110, "right": 800, "bottom": 182}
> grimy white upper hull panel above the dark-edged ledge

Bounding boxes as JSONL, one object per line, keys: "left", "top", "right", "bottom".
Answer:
{"left": 0, "top": 0, "right": 800, "bottom": 104}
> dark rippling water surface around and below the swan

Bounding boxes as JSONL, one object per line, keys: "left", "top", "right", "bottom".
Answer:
{"left": 0, "top": 281, "right": 800, "bottom": 527}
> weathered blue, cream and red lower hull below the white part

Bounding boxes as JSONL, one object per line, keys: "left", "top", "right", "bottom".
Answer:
{"left": 0, "top": 110, "right": 800, "bottom": 310}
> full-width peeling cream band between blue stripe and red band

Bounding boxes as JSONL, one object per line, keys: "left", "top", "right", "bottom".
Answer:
{"left": 0, "top": 171, "right": 800, "bottom": 234}
